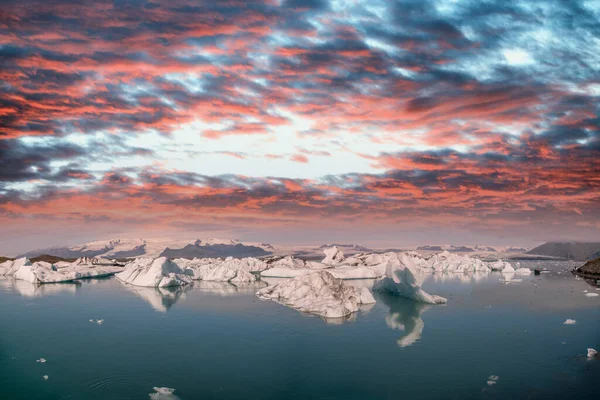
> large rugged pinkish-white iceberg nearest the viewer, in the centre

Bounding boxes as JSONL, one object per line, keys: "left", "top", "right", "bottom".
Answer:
{"left": 256, "top": 271, "right": 375, "bottom": 318}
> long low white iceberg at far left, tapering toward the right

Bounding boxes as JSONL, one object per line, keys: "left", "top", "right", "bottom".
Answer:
{"left": 14, "top": 261, "right": 123, "bottom": 284}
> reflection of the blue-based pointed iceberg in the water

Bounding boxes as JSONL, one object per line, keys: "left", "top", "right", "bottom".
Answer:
{"left": 377, "top": 293, "right": 431, "bottom": 347}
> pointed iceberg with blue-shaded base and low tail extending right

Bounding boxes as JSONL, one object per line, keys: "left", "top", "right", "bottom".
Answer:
{"left": 373, "top": 254, "right": 447, "bottom": 304}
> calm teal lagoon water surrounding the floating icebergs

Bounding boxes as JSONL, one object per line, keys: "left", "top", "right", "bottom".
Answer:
{"left": 0, "top": 261, "right": 600, "bottom": 400}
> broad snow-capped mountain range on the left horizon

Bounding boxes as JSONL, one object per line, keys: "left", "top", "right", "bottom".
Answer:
{"left": 19, "top": 238, "right": 275, "bottom": 259}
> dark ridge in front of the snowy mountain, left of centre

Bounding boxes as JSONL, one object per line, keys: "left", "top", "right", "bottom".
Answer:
{"left": 160, "top": 241, "right": 271, "bottom": 259}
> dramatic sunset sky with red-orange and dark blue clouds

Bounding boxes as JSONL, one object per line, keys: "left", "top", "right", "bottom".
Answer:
{"left": 0, "top": 0, "right": 600, "bottom": 254}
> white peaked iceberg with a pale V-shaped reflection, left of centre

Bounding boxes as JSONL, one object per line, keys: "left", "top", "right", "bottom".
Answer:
{"left": 116, "top": 257, "right": 192, "bottom": 287}
